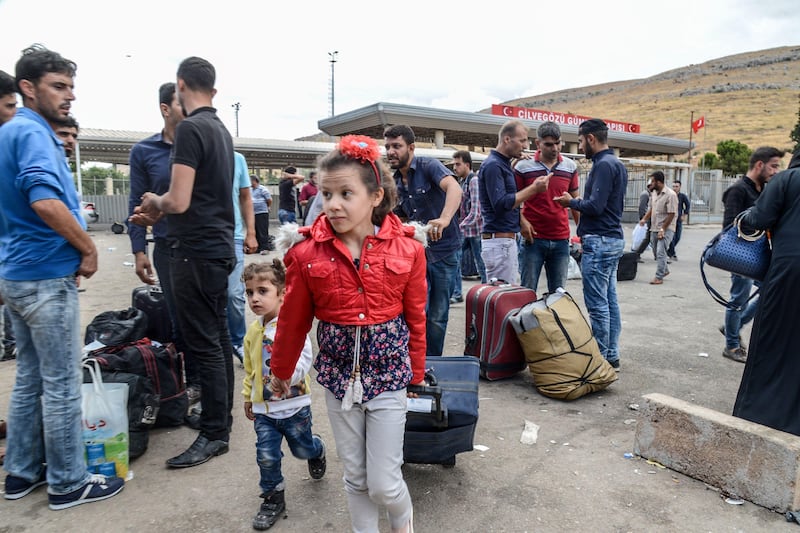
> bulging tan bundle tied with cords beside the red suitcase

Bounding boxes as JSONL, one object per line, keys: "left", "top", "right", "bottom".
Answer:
{"left": 510, "top": 291, "right": 617, "bottom": 400}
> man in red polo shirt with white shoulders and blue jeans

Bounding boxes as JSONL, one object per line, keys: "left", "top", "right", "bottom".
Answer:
{"left": 514, "top": 121, "right": 580, "bottom": 293}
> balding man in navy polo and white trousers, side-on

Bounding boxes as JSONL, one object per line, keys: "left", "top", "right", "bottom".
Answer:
{"left": 478, "top": 120, "right": 550, "bottom": 283}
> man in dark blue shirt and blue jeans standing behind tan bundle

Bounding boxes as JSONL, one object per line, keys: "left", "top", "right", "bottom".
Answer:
{"left": 555, "top": 118, "right": 628, "bottom": 370}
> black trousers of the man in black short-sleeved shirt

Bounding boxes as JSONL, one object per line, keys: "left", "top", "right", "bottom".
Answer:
{"left": 170, "top": 254, "right": 236, "bottom": 442}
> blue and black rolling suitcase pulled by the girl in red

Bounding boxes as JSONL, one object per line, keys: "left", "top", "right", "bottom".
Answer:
{"left": 403, "top": 356, "right": 480, "bottom": 466}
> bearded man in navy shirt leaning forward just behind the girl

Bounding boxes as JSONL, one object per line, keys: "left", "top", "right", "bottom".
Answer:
{"left": 383, "top": 125, "right": 461, "bottom": 355}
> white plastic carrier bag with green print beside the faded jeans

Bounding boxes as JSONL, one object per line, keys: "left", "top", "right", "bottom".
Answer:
{"left": 81, "top": 359, "right": 129, "bottom": 479}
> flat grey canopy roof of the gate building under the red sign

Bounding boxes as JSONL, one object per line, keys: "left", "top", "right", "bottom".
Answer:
{"left": 318, "top": 102, "right": 689, "bottom": 157}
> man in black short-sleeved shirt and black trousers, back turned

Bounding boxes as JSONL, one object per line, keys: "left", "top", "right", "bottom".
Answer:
{"left": 131, "top": 57, "right": 235, "bottom": 468}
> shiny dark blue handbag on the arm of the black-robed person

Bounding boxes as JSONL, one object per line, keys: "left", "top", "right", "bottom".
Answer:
{"left": 700, "top": 212, "right": 772, "bottom": 310}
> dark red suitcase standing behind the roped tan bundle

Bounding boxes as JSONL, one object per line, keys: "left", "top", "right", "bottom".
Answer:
{"left": 464, "top": 282, "right": 536, "bottom": 380}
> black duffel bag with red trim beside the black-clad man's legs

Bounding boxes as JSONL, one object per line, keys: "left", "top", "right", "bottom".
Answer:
{"left": 88, "top": 338, "right": 189, "bottom": 427}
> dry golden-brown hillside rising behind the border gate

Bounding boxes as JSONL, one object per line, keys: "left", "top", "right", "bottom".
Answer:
{"left": 504, "top": 46, "right": 800, "bottom": 161}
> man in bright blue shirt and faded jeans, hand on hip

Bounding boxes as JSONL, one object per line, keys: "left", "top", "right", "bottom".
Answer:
{"left": 0, "top": 45, "right": 124, "bottom": 504}
